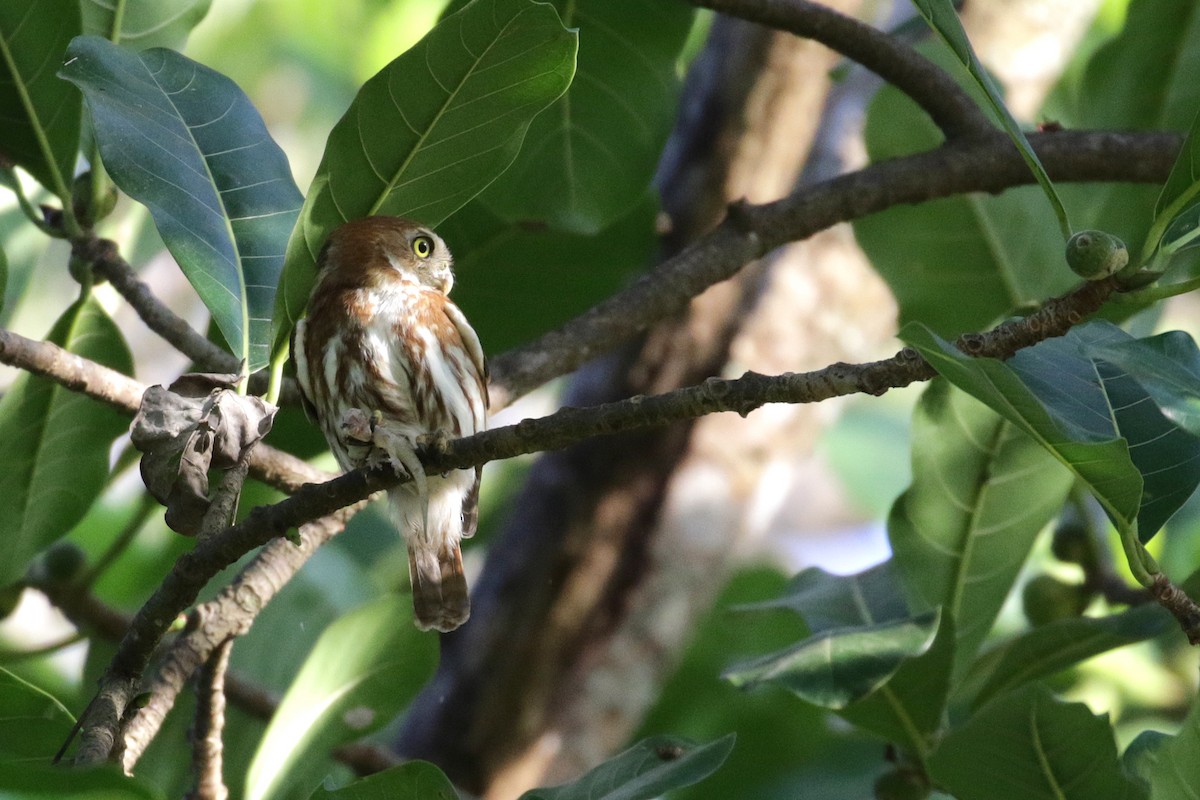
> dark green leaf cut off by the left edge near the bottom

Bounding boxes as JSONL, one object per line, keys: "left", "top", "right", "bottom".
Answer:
{"left": 0, "top": 667, "right": 74, "bottom": 767}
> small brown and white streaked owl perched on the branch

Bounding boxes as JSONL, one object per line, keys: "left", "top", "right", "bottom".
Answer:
{"left": 292, "top": 216, "right": 487, "bottom": 631}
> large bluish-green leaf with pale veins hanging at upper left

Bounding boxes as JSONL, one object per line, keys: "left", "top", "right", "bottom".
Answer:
{"left": 60, "top": 36, "right": 302, "bottom": 372}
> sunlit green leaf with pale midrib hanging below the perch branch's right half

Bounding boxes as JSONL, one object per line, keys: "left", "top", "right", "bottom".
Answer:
{"left": 888, "top": 380, "right": 1073, "bottom": 669}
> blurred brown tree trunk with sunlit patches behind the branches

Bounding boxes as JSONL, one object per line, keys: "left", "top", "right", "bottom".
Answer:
{"left": 400, "top": 0, "right": 1099, "bottom": 800}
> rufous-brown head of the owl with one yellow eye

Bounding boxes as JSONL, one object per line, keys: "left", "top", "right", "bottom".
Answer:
{"left": 318, "top": 217, "right": 454, "bottom": 294}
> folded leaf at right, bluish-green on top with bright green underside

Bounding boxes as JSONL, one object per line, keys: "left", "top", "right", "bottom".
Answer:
{"left": 901, "top": 323, "right": 1200, "bottom": 541}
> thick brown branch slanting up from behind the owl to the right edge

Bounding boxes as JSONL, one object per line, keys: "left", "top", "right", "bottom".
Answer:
{"left": 490, "top": 131, "right": 1181, "bottom": 408}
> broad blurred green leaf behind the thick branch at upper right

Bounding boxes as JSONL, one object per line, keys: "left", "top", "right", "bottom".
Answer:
{"left": 854, "top": 48, "right": 1080, "bottom": 336}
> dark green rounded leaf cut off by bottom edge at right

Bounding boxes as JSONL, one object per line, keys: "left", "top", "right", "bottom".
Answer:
{"left": 929, "top": 686, "right": 1144, "bottom": 800}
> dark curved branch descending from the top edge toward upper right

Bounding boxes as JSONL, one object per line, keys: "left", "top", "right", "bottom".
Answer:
{"left": 692, "top": 0, "right": 995, "bottom": 139}
